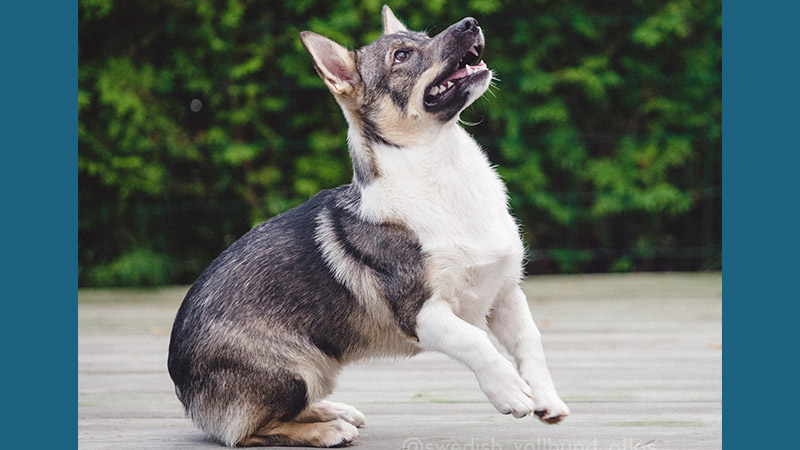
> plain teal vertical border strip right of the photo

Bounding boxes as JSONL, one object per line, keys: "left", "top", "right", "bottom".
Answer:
{"left": 722, "top": 1, "right": 800, "bottom": 449}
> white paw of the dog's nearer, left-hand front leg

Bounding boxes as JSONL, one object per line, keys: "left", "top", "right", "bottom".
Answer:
{"left": 478, "top": 360, "right": 535, "bottom": 418}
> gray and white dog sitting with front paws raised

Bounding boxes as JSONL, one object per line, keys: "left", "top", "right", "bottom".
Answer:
{"left": 168, "top": 7, "right": 569, "bottom": 447}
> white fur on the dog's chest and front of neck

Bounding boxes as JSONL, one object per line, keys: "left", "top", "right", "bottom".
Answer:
{"left": 360, "top": 124, "right": 523, "bottom": 323}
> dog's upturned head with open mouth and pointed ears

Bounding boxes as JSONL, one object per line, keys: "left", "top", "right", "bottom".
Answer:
{"left": 300, "top": 6, "right": 492, "bottom": 146}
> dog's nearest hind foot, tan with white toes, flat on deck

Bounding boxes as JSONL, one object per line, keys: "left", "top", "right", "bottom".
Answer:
{"left": 239, "top": 419, "right": 358, "bottom": 447}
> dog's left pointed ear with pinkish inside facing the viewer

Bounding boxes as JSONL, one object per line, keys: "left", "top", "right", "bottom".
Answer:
{"left": 300, "top": 31, "right": 361, "bottom": 95}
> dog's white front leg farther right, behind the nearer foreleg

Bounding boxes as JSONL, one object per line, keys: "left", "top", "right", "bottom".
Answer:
{"left": 489, "top": 285, "right": 569, "bottom": 423}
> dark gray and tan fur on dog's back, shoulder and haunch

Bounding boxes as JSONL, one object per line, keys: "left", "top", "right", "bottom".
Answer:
{"left": 168, "top": 185, "right": 429, "bottom": 445}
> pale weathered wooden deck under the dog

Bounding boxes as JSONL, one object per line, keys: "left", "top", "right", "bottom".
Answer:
{"left": 78, "top": 273, "right": 722, "bottom": 450}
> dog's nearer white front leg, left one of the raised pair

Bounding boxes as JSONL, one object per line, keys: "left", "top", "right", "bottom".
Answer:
{"left": 416, "top": 299, "right": 534, "bottom": 418}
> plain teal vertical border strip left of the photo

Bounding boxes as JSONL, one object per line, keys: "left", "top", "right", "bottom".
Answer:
{"left": 0, "top": 2, "right": 78, "bottom": 448}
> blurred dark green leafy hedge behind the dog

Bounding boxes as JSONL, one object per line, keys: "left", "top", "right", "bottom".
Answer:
{"left": 78, "top": 0, "right": 722, "bottom": 287}
